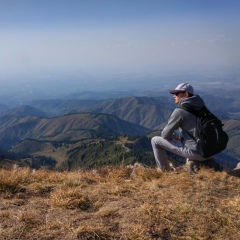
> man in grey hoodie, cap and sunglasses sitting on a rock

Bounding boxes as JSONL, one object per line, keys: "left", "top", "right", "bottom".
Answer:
{"left": 151, "top": 83, "right": 211, "bottom": 172}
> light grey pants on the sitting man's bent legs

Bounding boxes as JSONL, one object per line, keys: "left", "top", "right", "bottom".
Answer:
{"left": 151, "top": 136, "right": 208, "bottom": 171}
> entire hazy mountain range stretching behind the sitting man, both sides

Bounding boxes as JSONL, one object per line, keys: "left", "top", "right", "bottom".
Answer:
{"left": 0, "top": 96, "right": 240, "bottom": 169}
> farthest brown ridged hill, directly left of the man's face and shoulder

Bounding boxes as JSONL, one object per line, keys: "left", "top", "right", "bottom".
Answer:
{"left": 75, "top": 97, "right": 174, "bottom": 129}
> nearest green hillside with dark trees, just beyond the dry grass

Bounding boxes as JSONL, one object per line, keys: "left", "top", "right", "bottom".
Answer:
{"left": 8, "top": 135, "right": 155, "bottom": 170}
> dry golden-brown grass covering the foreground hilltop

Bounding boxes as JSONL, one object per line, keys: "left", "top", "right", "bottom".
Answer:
{"left": 0, "top": 167, "right": 240, "bottom": 240}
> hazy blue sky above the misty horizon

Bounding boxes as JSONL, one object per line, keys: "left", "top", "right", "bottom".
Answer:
{"left": 0, "top": 0, "right": 240, "bottom": 82}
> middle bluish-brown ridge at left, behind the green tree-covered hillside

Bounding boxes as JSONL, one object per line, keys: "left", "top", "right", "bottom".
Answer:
{"left": 0, "top": 113, "right": 149, "bottom": 150}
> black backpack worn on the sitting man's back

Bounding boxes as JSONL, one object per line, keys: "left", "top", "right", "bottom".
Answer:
{"left": 179, "top": 104, "right": 228, "bottom": 158}
